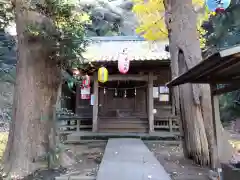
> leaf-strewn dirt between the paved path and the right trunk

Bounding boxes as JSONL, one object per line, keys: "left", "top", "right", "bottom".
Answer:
{"left": 146, "top": 142, "right": 209, "bottom": 180}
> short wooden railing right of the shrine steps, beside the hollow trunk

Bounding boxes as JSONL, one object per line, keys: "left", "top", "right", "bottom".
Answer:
{"left": 154, "top": 116, "right": 179, "bottom": 132}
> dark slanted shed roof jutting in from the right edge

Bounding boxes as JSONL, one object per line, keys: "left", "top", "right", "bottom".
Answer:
{"left": 167, "top": 46, "right": 240, "bottom": 94}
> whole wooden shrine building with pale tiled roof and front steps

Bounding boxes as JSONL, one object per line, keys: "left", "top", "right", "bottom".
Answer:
{"left": 60, "top": 37, "right": 178, "bottom": 133}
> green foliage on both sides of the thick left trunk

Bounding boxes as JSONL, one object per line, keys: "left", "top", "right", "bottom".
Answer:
{"left": 0, "top": 0, "right": 91, "bottom": 93}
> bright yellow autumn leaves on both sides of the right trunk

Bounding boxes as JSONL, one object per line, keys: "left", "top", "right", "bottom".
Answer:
{"left": 133, "top": 0, "right": 211, "bottom": 47}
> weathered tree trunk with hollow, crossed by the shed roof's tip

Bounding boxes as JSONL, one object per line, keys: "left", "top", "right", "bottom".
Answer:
{"left": 164, "top": 0, "right": 215, "bottom": 165}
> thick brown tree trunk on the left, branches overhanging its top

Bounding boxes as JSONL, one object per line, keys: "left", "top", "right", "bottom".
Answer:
{"left": 4, "top": 0, "right": 60, "bottom": 177}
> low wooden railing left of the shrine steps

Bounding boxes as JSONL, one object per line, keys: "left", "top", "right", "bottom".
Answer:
{"left": 57, "top": 116, "right": 92, "bottom": 134}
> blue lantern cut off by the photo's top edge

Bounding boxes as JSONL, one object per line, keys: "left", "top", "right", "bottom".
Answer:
{"left": 206, "top": 0, "right": 231, "bottom": 12}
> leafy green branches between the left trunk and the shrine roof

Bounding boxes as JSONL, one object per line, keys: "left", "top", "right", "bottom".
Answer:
{"left": 28, "top": 0, "right": 90, "bottom": 68}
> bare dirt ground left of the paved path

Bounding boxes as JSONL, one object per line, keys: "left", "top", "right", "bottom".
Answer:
{"left": 0, "top": 141, "right": 106, "bottom": 180}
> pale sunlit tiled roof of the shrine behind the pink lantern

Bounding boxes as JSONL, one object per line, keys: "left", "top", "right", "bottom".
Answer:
{"left": 83, "top": 37, "right": 170, "bottom": 62}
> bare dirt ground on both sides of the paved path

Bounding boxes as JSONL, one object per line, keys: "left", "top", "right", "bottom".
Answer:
{"left": 67, "top": 141, "right": 209, "bottom": 180}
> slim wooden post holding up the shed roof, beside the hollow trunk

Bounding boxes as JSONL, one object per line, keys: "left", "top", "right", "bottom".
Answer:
{"left": 211, "top": 86, "right": 221, "bottom": 169}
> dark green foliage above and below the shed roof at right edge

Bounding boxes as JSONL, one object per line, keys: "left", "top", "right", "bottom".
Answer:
{"left": 202, "top": 0, "right": 240, "bottom": 122}
